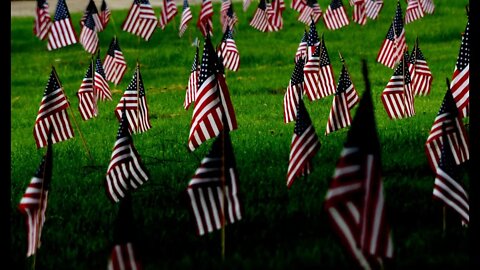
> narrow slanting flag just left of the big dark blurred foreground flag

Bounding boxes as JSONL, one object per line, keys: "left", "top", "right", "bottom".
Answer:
{"left": 287, "top": 96, "right": 320, "bottom": 188}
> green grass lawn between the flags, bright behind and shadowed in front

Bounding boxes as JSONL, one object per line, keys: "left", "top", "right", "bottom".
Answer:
{"left": 11, "top": 0, "right": 468, "bottom": 269}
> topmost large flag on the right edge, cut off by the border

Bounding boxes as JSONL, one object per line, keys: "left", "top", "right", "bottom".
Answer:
{"left": 450, "top": 18, "right": 470, "bottom": 117}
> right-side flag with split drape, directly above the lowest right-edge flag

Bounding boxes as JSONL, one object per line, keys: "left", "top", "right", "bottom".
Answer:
{"left": 425, "top": 82, "right": 470, "bottom": 172}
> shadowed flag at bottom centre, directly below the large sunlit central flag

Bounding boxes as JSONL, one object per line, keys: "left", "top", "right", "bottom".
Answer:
{"left": 187, "top": 131, "right": 243, "bottom": 235}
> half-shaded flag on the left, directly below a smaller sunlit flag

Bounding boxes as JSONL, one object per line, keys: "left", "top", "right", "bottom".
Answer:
{"left": 105, "top": 99, "right": 149, "bottom": 202}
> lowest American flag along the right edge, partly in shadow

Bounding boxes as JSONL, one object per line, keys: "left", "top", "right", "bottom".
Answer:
{"left": 433, "top": 124, "right": 469, "bottom": 224}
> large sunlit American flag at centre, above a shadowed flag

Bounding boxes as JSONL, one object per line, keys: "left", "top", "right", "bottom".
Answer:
{"left": 188, "top": 35, "right": 237, "bottom": 151}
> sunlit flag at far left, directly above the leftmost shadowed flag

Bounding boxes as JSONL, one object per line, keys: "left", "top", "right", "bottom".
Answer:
{"left": 33, "top": 66, "right": 74, "bottom": 148}
